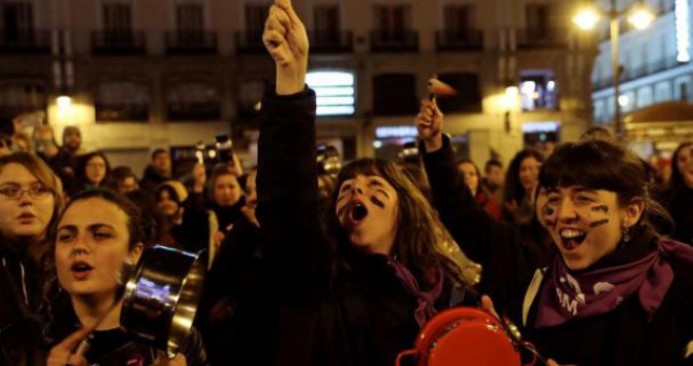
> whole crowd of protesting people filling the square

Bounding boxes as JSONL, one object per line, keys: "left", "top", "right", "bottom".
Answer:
{"left": 0, "top": 0, "right": 693, "bottom": 366}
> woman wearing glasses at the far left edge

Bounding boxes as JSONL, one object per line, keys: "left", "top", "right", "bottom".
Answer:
{"left": 0, "top": 152, "right": 63, "bottom": 366}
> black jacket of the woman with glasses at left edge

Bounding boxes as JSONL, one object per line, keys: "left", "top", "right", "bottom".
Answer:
{"left": 0, "top": 245, "right": 43, "bottom": 366}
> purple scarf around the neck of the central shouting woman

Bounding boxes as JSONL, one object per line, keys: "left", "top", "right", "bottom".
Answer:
{"left": 388, "top": 258, "right": 443, "bottom": 327}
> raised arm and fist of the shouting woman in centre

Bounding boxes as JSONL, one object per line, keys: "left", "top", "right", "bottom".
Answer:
{"left": 257, "top": 0, "right": 326, "bottom": 294}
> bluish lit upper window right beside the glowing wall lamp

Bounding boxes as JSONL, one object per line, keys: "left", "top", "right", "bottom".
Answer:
{"left": 519, "top": 70, "right": 558, "bottom": 111}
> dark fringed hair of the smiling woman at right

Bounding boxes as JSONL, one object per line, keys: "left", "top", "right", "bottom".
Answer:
{"left": 539, "top": 139, "right": 673, "bottom": 232}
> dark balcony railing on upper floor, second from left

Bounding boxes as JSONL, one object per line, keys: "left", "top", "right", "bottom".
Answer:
{"left": 91, "top": 30, "right": 146, "bottom": 55}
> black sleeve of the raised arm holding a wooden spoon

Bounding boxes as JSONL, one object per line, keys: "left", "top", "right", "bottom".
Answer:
{"left": 419, "top": 136, "right": 531, "bottom": 319}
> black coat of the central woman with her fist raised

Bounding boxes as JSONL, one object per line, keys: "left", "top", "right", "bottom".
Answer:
{"left": 220, "top": 90, "right": 470, "bottom": 366}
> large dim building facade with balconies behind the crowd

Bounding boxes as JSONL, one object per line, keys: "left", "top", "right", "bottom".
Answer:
{"left": 0, "top": 0, "right": 596, "bottom": 172}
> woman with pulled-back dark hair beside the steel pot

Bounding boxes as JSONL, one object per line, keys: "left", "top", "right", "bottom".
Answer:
{"left": 46, "top": 190, "right": 208, "bottom": 366}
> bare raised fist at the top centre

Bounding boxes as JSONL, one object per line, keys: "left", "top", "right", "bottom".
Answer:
{"left": 262, "top": 0, "right": 308, "bottom": 95}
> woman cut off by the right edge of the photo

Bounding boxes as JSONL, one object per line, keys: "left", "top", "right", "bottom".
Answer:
{"left": 659, "top": 142, "right": 693, "bottom": 245}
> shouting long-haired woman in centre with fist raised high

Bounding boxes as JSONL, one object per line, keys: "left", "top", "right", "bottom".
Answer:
{"left": 216, "top": 0, "right": 476, "bottom": 366}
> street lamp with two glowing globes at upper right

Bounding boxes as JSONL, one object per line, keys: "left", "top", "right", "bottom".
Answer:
{"left": 573, "top": 0, "right": 654, "bottom": 136}
